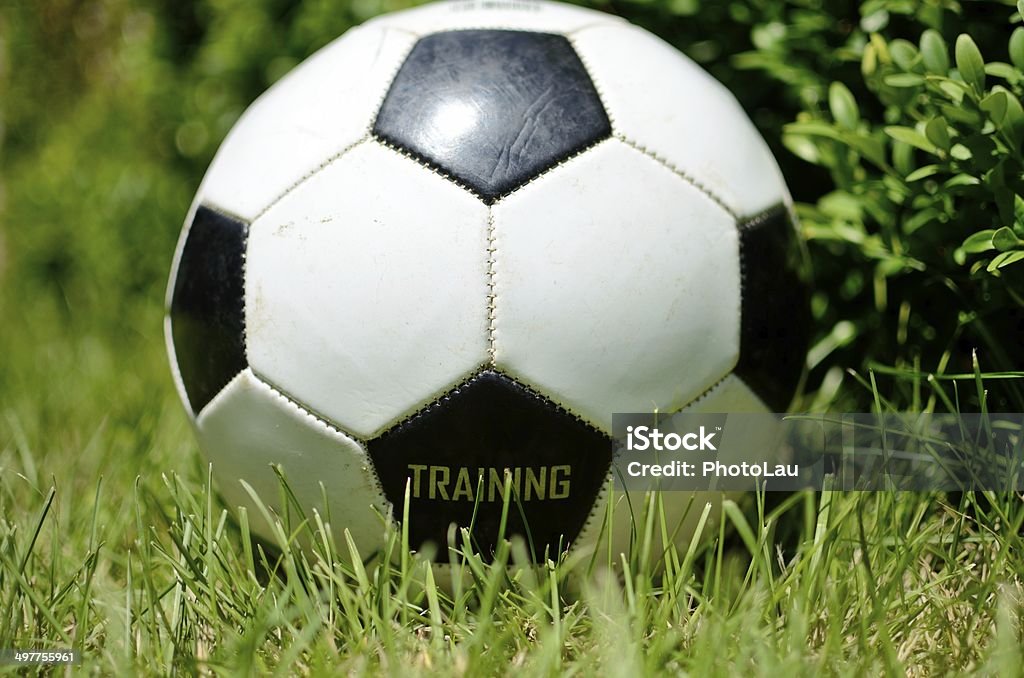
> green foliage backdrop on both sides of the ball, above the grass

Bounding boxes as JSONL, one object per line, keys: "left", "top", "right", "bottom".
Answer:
{"left": 0, "top": 0, "right": 1024, "bottom": 450}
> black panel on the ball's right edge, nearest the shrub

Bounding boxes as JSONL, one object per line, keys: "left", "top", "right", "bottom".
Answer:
{"left": 735, "top": 206, "right": 811, "bottom": 412}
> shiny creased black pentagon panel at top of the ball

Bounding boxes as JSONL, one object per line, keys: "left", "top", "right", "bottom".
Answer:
{"left": 374, "top": 31, "right": 611, "bottom": 203}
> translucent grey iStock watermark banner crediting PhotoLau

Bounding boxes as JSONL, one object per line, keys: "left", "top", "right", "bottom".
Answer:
{"left": 612, "top": 413, "right": 1024, "bottom": 492}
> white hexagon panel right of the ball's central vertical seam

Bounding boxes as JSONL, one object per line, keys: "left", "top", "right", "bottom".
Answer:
{"left": 493, "top": 139, "right": 740, "bottom": 431}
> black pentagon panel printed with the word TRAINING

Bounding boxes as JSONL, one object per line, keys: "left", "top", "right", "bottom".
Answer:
{"left": 369, "top": 370, "right": 611, "bottom": 562}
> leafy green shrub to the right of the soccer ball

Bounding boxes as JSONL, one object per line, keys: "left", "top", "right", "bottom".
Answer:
{"left": 783, "top": 10, "right": 1024, "bottom": 409}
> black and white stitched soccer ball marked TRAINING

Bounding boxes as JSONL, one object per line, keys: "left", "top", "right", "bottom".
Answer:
{"left": 166, "top": 0, "right": 808, "bottom": 560}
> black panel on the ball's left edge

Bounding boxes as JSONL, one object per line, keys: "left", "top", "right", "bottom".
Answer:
{"left": 171, "top": 206, "right": 249, "bottom": 414}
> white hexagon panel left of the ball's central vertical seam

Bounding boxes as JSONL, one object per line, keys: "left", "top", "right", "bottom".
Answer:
{"left": 245, "top": 141, "right": 487, "bottom": 438}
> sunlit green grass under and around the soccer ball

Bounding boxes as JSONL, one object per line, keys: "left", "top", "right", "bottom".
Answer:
{"left": 0, "top": 301, "right": 1024, "bottom": 675}
